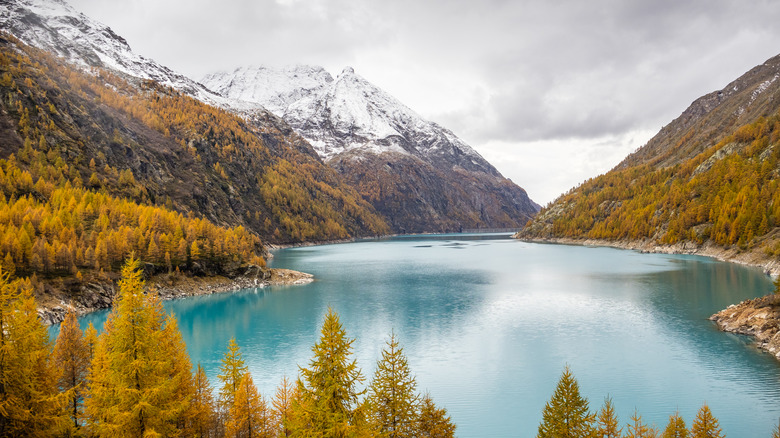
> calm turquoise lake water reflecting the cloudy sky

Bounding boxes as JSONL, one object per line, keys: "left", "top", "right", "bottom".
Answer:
{"left": 68, "top": 235, "right": 780, "bottom": 437}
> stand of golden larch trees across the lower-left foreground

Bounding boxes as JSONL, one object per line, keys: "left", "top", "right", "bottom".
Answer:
{"left": 0, "top": 259, "right": 455, "bottom": 438}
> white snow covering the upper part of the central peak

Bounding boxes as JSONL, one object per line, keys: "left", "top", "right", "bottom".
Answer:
{"left": 202, "top": 65, "right": 498, "bottom": 176}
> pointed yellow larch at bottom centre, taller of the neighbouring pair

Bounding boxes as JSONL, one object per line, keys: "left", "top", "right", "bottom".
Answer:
{"left": 293, "top": 308, "right": 363, "bottom": 437}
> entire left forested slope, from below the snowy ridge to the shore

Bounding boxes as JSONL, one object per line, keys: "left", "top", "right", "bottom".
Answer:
{"left": 0, "top": 34, "right": 388, "bottom": 313}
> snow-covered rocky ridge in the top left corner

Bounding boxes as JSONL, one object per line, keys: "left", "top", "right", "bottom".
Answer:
{"left": 0, "top": 0, "right": 224, "bottom": 104}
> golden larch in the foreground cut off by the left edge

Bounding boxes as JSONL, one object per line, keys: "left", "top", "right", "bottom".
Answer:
{"left": 0, "top": 267, "right": 65, "bottom": 437}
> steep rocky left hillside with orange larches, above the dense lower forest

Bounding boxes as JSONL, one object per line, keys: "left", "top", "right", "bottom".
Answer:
{"left": 0, "top": 37, "right": 387, "bottom": 246}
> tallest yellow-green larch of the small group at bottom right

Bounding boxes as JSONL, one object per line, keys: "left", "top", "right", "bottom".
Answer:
{"left": 537, "top": 365, "right": 595, "bottom": 438}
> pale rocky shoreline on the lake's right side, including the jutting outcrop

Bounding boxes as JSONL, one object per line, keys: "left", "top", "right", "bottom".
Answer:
{"left": 521, "top": 238, "right": 780, "bottom": 360}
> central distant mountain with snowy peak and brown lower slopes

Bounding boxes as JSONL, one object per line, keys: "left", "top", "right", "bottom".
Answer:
{"left": 202, "top": 66, "right": 539, "bottom": 232}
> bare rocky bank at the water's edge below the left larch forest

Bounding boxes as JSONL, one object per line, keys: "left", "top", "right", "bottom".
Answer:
{"left": 38, "top": 266, "right": 314, "bottom": 325}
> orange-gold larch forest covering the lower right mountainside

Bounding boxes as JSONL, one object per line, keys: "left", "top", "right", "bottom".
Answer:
{"left": 524, "top": 114, "right": 780, "bottom": 255}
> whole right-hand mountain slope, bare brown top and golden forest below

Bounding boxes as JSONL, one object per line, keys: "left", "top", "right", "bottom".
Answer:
{"left": 520, "top": 51, "right": 780, "bottom": 265}
